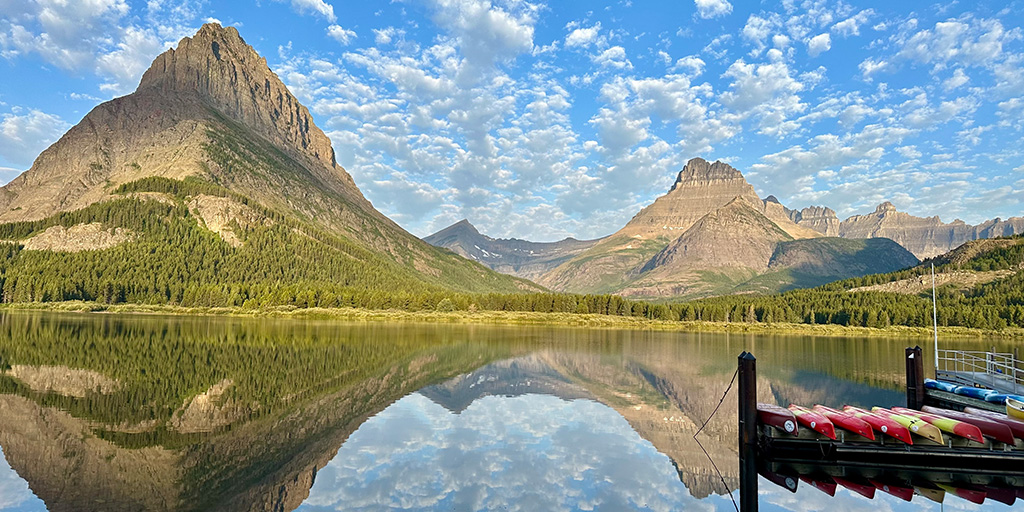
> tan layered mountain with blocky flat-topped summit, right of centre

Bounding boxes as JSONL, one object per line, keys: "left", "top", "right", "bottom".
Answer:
{"left": 538, "top": 159, "right": 918, "bottom": 298}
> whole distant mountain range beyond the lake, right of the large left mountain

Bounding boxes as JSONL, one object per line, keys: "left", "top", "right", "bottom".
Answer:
{"left": 424, "top": 159, "right": 1024, "bottom": 299}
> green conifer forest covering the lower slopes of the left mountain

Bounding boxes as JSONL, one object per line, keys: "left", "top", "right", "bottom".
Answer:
{"left": 0, "top": 178, "right": 537, "bottom": 306}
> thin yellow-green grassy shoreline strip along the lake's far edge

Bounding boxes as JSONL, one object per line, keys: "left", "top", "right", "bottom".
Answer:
{"left": 0, "top": 301, "right": 1024, "bottom": 339}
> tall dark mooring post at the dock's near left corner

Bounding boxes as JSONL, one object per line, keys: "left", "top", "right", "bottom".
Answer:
{"left": 738, "top": 351, "right": 758, "bottom": 512}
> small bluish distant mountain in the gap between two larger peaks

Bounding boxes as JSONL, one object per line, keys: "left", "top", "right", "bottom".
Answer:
{"left": 423, "top": 219, "right": 598, "bottom": 280}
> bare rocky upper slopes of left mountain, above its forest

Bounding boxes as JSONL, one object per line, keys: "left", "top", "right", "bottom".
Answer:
{"left": 0, "top": 24, "right": 541, "bottom": 300}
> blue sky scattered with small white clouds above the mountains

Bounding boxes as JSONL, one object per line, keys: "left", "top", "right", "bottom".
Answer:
{"left": 0, "top": 0, "right": 1024, "bottom": 241}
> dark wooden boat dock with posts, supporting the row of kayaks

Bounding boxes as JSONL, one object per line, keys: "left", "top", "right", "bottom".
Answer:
{"left": 737, "top": 347, "right": 1024, "bottom": 512}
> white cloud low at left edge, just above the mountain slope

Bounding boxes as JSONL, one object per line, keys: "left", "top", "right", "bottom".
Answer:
{"left": 0, "top": 108, "right": 71, "bottom": 168}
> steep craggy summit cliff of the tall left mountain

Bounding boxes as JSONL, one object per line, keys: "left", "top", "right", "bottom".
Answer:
{"left": 136, "top": 24, "right": 337, "bottom": 168}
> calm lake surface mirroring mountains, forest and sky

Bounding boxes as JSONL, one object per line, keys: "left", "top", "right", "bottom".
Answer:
{"left": 0, "top": 312, "right": 1010, "bottom": 511}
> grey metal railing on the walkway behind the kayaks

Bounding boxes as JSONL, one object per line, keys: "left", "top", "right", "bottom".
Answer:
{"left": 935, "top": 350, "right": 1024, "bottom": 393}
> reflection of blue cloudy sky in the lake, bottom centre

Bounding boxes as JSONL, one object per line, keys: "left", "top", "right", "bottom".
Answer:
{"left": 299, "top": 394, "right": 732, "bottom": 511}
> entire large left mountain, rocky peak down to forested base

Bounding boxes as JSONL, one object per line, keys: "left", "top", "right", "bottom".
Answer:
{"left": 0, "top": 24, "right": 541, "bottom": 305}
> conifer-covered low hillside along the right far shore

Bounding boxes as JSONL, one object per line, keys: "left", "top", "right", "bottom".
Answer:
{"left": 681, "top": 236, "right": 1024, "bottom": 329}
